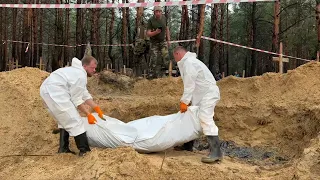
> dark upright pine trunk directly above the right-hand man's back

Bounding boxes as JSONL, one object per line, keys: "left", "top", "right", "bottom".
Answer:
{"left": 209, "top": 4, "right": 218, "bottom": 75}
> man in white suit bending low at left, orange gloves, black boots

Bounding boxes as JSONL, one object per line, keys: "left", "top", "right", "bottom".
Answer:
{"left": 40, "top": 55, "right": 103, "bottom": 156}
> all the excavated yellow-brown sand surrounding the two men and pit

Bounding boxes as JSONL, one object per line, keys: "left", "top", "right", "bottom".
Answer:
{"left": 0, "top": 63, "right": 320, "bottom": 179}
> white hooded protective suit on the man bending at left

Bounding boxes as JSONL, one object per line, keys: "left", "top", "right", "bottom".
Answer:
{"left": 40, "top": 58, "right": 92, "bottom": 136}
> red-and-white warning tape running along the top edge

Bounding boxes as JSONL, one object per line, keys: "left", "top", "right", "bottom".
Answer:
{"left": 0, "top": 0, "right": 275, "bottom": 9}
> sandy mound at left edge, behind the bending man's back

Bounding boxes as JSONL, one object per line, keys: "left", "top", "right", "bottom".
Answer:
{"left": 0, "top": 68, "right": 56, "bottom": 155}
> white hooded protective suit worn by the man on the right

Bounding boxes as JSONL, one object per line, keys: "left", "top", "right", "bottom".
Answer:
{"left": 177, "top": 52, "right": 220, "bottom": 136}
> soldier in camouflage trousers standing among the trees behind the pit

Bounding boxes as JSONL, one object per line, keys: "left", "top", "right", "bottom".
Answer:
{"left": 147, "top": 6, "right": 170, "bottom": 78}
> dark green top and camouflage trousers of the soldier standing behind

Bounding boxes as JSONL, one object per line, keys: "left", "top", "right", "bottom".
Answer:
{"left": 148, "top": 16, "right": 169, "bottom": 78}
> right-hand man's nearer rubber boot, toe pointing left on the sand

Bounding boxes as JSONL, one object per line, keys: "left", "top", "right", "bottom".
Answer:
{"left": 201, "top": 136, "right": 222, "bottom": 163}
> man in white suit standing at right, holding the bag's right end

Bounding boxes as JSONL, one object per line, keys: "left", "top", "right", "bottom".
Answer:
{"left": 173, "top": 46, "right": 222, "bottom": 163}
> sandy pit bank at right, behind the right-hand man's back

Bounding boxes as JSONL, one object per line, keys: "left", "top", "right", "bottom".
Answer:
{"left": 216, "top": 63, "right": 320, "bottom": 157}
